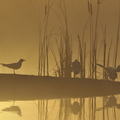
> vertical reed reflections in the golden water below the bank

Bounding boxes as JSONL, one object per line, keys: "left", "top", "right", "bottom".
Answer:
{"left": 38, "top": 96, "right": 120, "bottom": 120}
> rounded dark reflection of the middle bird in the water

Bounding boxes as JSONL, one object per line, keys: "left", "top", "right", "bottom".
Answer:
{"left": 70, "top": 102, "right": 82, "bottom": 115}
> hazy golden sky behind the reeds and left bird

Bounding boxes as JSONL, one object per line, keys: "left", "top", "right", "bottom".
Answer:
{"left": 0, "top": 0, "right": 119, "bottom": 74}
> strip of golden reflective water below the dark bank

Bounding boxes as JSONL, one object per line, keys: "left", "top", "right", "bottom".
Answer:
{"left": 0, "top": 95, "right": 120, "bottom": 120}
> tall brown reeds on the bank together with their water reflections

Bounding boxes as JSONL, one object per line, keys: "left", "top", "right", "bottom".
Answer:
{"left": 31, "top": 0, "right": 120, "bottom": 120}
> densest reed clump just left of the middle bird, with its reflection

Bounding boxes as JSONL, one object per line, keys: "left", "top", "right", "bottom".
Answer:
{"left": 49, "top": 1, "right": 72, "bottom": 120}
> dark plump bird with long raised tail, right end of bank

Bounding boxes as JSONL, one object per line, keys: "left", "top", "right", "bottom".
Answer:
{"left": 97, "top": 64, "right": 117, "bottom": 81}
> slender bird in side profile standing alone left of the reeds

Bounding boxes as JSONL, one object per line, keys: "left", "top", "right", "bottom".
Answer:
{"left": 0, "top": 59, "right": 26, "bottom": 74}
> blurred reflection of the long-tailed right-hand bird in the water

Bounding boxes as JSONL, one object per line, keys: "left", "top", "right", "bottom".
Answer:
{"left": 96, "top": 96, "right": 120, "bottom": 111}
